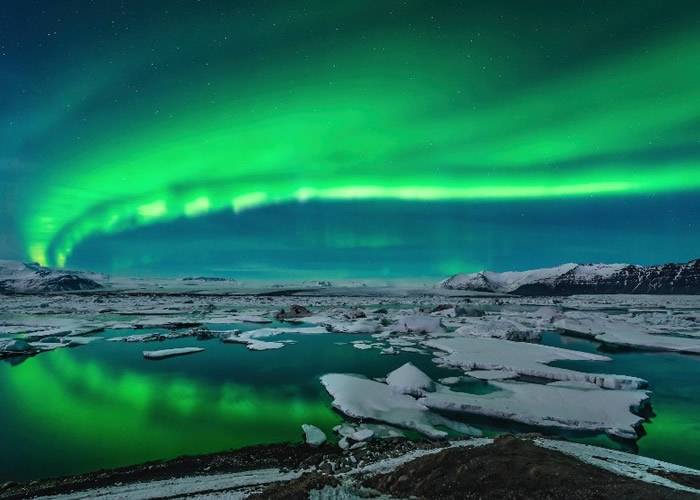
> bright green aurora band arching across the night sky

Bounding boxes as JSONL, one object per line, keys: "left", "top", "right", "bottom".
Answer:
{"left": 15, "top": 15, "right": 700, "bottom": 266}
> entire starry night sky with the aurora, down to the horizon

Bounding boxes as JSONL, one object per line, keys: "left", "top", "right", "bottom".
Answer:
{"left": 0, "top": 0, "right": 700, "bottom": 279}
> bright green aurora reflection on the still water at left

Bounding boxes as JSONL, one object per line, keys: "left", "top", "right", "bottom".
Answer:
{"left": 6, "top": 350, "right": 341, "bottom": 467}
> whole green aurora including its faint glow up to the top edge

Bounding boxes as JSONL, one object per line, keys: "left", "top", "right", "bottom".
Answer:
{"left": 0, "top": 2, "right": 700, "bottom": 274}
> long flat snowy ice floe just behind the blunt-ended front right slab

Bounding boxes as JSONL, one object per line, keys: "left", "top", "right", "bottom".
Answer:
{"left": 424, "top": 337, "right": 646, "bottom": 389}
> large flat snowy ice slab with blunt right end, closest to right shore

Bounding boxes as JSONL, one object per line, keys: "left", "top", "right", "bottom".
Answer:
{"left": 419, "top": 382, "right": 649, "bottom": 439}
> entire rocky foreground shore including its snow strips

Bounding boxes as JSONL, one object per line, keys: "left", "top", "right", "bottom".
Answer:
{"left": 0, "top": 436, "right": 700, "bottom": 500}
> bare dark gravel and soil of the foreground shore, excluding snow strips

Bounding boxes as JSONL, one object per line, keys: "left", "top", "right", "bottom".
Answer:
{"left": 0, "top": 436, "right": 700, "bottom": 500}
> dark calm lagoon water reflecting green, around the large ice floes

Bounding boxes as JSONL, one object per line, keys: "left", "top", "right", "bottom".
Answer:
{"left": 0, "top": 325, "right": 700, "bottom": 480}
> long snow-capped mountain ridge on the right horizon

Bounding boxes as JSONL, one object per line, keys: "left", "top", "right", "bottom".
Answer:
{"left": 440, "top": 259, "right": 700, "bottom": 295}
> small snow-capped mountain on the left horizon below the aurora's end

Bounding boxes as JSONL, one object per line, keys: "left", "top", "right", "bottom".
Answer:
{"left": 0, "top": 260, "right": 104, "bottom": 293}
